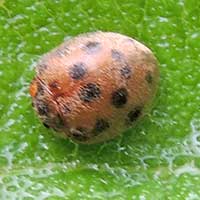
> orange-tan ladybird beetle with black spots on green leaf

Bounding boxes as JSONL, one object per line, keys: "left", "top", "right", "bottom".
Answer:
{"left": 30, "top": 31, "right": 159, "bottom": 144}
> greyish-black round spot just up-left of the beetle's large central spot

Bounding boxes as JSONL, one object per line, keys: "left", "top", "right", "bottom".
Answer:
{"left": 69, "top": 62, "right": 87, "bottom": 80}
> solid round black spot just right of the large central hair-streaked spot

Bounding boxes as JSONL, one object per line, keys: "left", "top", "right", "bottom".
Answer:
{"left": 111, "top": 88, "right": 128, "bottom": 108}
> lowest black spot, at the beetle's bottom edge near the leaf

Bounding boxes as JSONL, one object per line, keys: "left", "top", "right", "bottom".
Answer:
{"left": 70, "top": 127, "right": 88, "bottom": 141}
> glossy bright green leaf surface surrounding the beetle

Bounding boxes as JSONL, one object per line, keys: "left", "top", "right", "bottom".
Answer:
{"left": 0, "top": 0, "right": 200, "bottom": 200}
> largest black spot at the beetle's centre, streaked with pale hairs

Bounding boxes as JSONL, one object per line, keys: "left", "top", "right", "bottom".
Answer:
{"left": 79, "top": 83, "right": 101, "bottom": 102}
